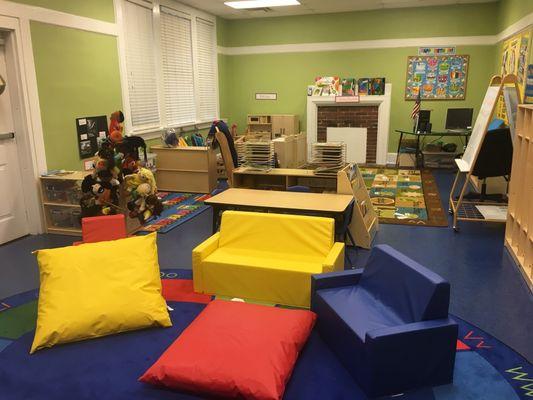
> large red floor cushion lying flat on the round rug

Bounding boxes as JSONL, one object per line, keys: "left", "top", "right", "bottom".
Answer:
{"left": 140, "top": 300, "right": 316, "bottom": 400}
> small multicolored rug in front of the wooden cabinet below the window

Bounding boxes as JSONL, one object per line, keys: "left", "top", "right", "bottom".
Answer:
{"left": 137, "top": 192, "right": 211, "bottom": 235}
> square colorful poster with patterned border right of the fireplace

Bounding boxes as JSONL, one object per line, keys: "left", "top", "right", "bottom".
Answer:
{"left": 405, "top": 55, "right": 469, "bottom": 100}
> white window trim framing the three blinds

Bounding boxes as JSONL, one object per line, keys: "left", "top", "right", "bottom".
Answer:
{"left": 114, "top": 0, "right": 220, "bottom": 139}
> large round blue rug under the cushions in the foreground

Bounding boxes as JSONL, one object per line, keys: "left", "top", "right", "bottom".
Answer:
{"left": 0, "top": 270, "right": 533, "bottom": 400}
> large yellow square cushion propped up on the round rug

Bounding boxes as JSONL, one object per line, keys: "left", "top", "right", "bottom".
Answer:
{"left": 30, "top": 233, "right": 172, "bottom": 353}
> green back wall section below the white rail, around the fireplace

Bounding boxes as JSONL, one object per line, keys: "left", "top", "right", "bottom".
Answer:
{"left": 221, "top": 46, "right": 495, "bottom": 151}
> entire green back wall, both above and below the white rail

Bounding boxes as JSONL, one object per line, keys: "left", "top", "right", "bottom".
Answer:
{"left": 218, "top": 3, "right": 499, "bottom": 152}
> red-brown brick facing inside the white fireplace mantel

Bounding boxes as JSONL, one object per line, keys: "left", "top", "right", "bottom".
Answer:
{"left": 317, "top": 104, "right": 378, "bottom": 164}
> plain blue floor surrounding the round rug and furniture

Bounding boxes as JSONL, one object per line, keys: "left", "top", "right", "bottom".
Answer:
{"left": 0, "top": 171, "right": 533, "bottom": 362}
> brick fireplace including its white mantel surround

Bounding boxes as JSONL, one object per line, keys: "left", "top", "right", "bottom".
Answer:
{"left": 307, "top": 83, "right": 392, "bottom": 165}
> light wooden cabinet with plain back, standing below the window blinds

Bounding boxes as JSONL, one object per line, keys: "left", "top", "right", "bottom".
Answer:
{"left": 151, "top": 146, "right": 217, "bottom": 193}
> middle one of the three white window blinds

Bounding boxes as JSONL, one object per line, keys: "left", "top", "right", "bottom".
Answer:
{"left": 161, "top": 7, "right": 196, "bottom": 126}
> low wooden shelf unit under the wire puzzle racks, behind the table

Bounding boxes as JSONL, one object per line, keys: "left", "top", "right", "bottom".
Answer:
{"left": 233, "top": 167, "right": 337, "bottom": 193}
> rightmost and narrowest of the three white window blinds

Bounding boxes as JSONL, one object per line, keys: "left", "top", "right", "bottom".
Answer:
{"left": 196, "top": 17, "right": 217, "bottom": 121}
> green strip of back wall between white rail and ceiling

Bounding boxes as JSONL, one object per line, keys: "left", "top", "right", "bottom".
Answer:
{"left": 219, "top": 0, "right": 498, "bottom": 46}
